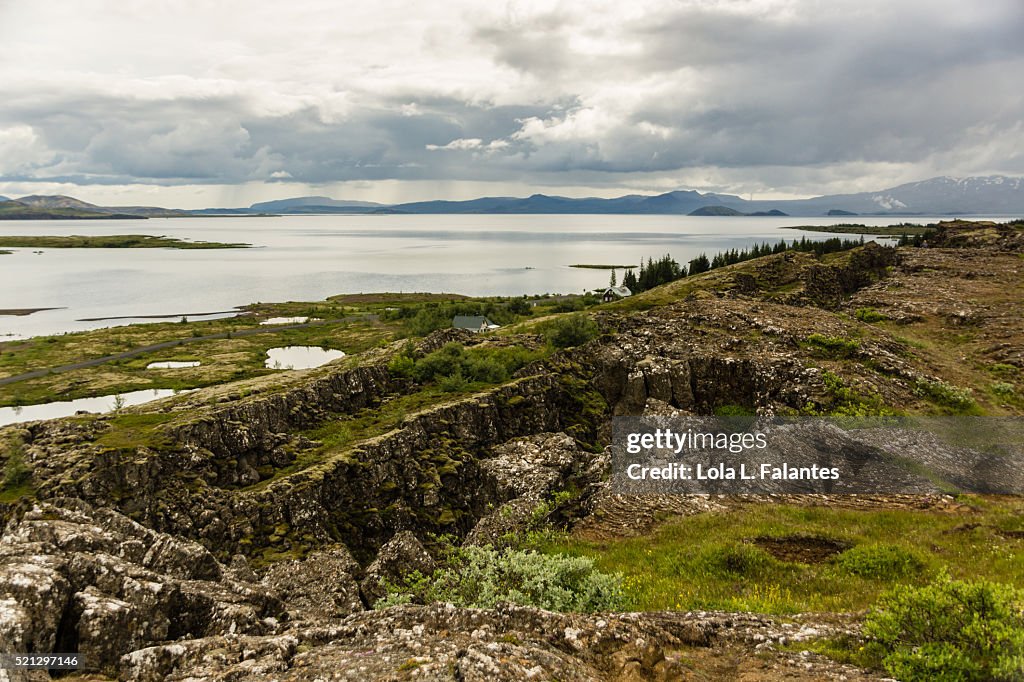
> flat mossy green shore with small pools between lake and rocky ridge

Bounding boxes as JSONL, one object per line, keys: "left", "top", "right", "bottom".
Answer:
{"left": 0, "top": 294, "right": 581, "bottom": 407}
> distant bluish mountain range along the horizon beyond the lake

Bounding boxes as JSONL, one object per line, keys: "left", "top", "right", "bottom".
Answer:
{"left": 0, "top": 175, "right": 1024, "bottom": 219}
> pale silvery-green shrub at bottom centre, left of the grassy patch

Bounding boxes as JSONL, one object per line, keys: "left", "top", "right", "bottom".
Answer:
{"left": 375, "top": 547, "right": 625, "bottom": 612}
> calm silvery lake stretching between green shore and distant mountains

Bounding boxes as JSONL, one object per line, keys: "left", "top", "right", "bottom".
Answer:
{"left": 0, "top": 215, "right": 999, "bottom": 341}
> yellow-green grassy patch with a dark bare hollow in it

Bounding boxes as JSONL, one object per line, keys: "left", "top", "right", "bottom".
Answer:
{"left": 541, "top": 497, "right": 1024, "bottom": 615}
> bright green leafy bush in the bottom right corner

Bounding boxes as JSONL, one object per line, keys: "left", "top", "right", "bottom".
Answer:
{"left": 864, "top": 574, "right": 1024, "bottom": 682}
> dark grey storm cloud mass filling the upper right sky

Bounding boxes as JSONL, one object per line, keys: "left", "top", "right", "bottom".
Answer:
{"left": 473, "top": 2, "right": 1024, "bottom": 172}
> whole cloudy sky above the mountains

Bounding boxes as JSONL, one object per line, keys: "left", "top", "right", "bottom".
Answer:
{"left": 0, "top": 0, "right": 1024, "bottom": 208}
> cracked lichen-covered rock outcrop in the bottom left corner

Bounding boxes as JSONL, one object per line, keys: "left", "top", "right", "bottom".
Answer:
{"left": 0, "top": 500, "right": 284, "bottom": 675}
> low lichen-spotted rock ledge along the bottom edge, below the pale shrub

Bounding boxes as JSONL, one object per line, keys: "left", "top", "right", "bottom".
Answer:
{"left": 116, "top": 604, "right": 707, "bottom": 682}
